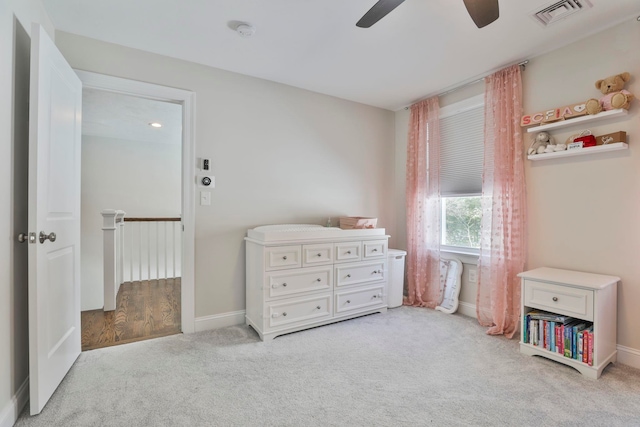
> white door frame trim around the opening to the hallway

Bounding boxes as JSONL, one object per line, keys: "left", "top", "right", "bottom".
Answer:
{"left": 74, "top": 69, "right": 196, "bottom": 334}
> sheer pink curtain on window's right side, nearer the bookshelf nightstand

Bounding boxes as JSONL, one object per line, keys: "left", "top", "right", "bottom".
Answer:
{"left": 476, "top": 65, "right": 527, "bottom": 338}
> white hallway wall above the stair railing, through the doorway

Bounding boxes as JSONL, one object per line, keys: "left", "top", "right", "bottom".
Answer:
{"left": 81, "top": 135, "right": 182, "bottom": 311}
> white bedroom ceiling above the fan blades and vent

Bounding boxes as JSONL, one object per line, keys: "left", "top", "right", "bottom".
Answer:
{"left": 43, "top": 0, "right": 640, "bottom": 110}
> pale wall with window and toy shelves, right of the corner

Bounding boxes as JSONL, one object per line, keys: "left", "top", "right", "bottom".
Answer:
{"left": 395, "top": 18, "right": 640, "bottom": 358}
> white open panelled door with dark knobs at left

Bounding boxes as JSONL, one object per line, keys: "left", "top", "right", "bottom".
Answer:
{"left": 28, "top": 24, "right": 82, "bottom": 415}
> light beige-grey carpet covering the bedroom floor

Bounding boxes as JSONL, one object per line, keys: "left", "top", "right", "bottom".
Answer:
{"left": 16, "top": 307, "right": 640, "bottom": 427}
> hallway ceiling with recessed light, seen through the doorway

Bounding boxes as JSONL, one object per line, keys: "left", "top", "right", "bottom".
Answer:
{"left": 82, "top": 89, "right": 182, "bottom": 145}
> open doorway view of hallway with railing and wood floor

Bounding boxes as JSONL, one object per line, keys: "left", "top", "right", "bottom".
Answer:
{"left": 80, "top": 88, "right": 182, "bottom": 350}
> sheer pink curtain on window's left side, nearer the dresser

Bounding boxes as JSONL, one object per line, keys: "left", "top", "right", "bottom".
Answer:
{"left": 404, "top": 97, "right": 442, "bottom": 308}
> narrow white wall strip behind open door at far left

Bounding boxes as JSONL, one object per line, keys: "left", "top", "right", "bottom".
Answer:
{"left": 0, "top": 0, "right": 54, "bottom": 427}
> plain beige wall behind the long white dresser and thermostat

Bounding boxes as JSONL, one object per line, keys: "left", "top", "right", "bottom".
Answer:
{"left": 56, "top": 32, "right": 395, "bottom": 317}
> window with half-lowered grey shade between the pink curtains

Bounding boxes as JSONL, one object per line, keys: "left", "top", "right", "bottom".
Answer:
{"left": 440, "top": 95, "right": 484, "bottom": 253}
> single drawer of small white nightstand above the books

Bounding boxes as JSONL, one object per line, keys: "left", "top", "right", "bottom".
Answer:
{"left": 524, "top": 279, "right": 593, "bottom": 321}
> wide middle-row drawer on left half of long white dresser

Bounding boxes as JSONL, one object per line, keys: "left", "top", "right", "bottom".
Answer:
{"left": 265, "top": 266, "right": 333, "bottom": 298}
